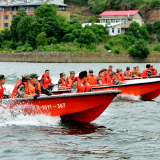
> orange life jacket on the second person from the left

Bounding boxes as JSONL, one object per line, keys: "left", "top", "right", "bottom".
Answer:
{"left": 11, "top": 79, "right": 29, "bottom": 98}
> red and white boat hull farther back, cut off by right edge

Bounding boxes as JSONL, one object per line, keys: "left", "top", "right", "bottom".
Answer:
{"left": 93, "top": 78, "right": 160, "bottom": 100}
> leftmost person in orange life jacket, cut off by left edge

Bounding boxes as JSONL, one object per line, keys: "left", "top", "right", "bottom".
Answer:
{"left": 0, "top": 74, "right": 10, "bottom": 100}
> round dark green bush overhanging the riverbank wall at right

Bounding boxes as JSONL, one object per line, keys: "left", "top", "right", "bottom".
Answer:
{"left": 128, "top": 39, "right": 149, "bottom": 58}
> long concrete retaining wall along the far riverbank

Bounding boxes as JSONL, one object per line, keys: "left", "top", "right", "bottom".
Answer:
{"left": 0, "top": 52, "right": 160, "bottom": 63}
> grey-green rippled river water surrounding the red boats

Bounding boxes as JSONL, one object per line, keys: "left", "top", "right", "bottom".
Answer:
{"left": 0, "top": 62, "right": 160, "bottom": 160}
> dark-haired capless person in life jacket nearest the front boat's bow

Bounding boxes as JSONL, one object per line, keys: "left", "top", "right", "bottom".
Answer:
{"left": 71, "top": 71, "right": 93, "bottom": 93}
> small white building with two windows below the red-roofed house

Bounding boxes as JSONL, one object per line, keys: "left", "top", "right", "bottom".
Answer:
{"left": 82, "top": 22, "right": 122, "bottom": 36}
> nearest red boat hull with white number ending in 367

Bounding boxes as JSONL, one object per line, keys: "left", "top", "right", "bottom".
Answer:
{"left": 0, "top": 90, "right": 121, "bottom": 122}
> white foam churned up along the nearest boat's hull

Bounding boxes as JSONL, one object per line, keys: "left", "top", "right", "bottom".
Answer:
{"left": 0, "top": 107, "right": 60, "bottom": 127}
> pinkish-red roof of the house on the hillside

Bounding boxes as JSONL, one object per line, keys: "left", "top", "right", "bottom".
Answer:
{"left": 100, "top": 10, "right": 139, "bottom": 16}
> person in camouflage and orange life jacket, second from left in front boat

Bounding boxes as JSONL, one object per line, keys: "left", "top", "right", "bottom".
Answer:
{"left": 11, "top": 74, "right": 36, "bottom": 98}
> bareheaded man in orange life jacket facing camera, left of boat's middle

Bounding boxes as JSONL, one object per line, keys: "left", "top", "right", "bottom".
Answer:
{"left": 41, "top": 69, "right": 56, "bottom": 91}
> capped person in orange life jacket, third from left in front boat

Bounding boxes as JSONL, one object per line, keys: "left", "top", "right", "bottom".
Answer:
{"left": 29, "top": 73, "right": 53, "bottom": 96}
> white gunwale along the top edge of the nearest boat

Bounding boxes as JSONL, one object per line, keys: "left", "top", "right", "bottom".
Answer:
{"left": 0, "top": 90, "right": 122, "bottom": 103}
